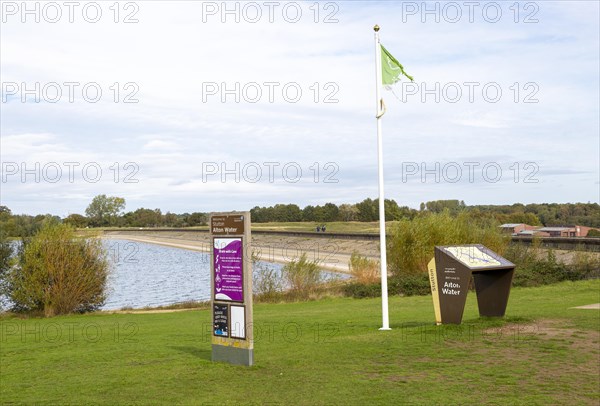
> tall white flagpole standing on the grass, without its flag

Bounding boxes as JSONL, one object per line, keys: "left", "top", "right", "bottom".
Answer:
{"left": 373, "top": 25, "right": 391, "bottom": 330}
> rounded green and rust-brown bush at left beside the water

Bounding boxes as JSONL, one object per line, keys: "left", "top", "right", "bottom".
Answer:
{"left": 7, "top": 224, "right": 109, "bottom": 317}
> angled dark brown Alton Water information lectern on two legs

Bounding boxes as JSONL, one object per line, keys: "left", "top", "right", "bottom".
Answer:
{"left": 428, "top": 244, "right": 515, "bottom": 324}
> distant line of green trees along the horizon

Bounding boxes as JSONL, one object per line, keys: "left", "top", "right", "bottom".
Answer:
{"left": 0, "top": 195, "right": 600, "bottom": 237}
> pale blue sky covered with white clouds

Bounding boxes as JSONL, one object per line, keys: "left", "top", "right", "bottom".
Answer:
{"left": 0, "top": 1, "right": 600, "bottom": 216}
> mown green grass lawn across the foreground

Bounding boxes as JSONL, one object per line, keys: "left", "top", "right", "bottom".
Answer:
{"left": 0, "top": 280, "right": 600, "bottom": 405}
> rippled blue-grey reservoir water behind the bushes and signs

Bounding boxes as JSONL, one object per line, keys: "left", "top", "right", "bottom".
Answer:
{"left": 102, "top": 239, "right": 343, "bottom": 310}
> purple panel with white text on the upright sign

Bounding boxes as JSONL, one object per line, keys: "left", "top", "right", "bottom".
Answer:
{"left": 213, "top": 238, "right": 244, "bottom": 302}
